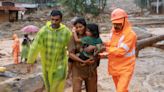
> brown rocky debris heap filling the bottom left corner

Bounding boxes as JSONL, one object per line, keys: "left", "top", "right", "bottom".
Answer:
{"left": 0, "top": 63, "right": 44, "bottom": 92}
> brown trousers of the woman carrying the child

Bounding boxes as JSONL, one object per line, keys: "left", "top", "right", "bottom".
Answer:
{"left": 72, "top": 63, "right": 97, "bottom": 92}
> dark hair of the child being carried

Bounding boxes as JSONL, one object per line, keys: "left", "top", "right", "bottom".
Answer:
{"left": 87, "top": 23, "right": 99, "bottom": 38}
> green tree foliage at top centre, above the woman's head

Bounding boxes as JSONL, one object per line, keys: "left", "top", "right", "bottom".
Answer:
{"left": 58, "top": 0, "right": 106, "bottom": 15}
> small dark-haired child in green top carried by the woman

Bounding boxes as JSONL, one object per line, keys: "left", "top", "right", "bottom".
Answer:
{"left": 73, "top": 23, "right": 102, "bottom": 60}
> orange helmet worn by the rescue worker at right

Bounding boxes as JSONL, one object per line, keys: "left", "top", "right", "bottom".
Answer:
{"left": 111, "top": 8, "right": 128, "bottom": 22}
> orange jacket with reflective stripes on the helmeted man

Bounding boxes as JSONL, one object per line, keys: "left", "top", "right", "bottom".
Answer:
{"left": 107, "top": 20, "right": 137, "bottom": 75}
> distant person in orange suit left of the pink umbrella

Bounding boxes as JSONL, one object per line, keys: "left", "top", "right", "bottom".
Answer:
{"left": 12, "top": 34, "right": 20, "bottom": 64}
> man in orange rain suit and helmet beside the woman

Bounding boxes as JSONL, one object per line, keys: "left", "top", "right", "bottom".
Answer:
{"left": 105, "top": 8, "right": 137, "bottom": 92}
